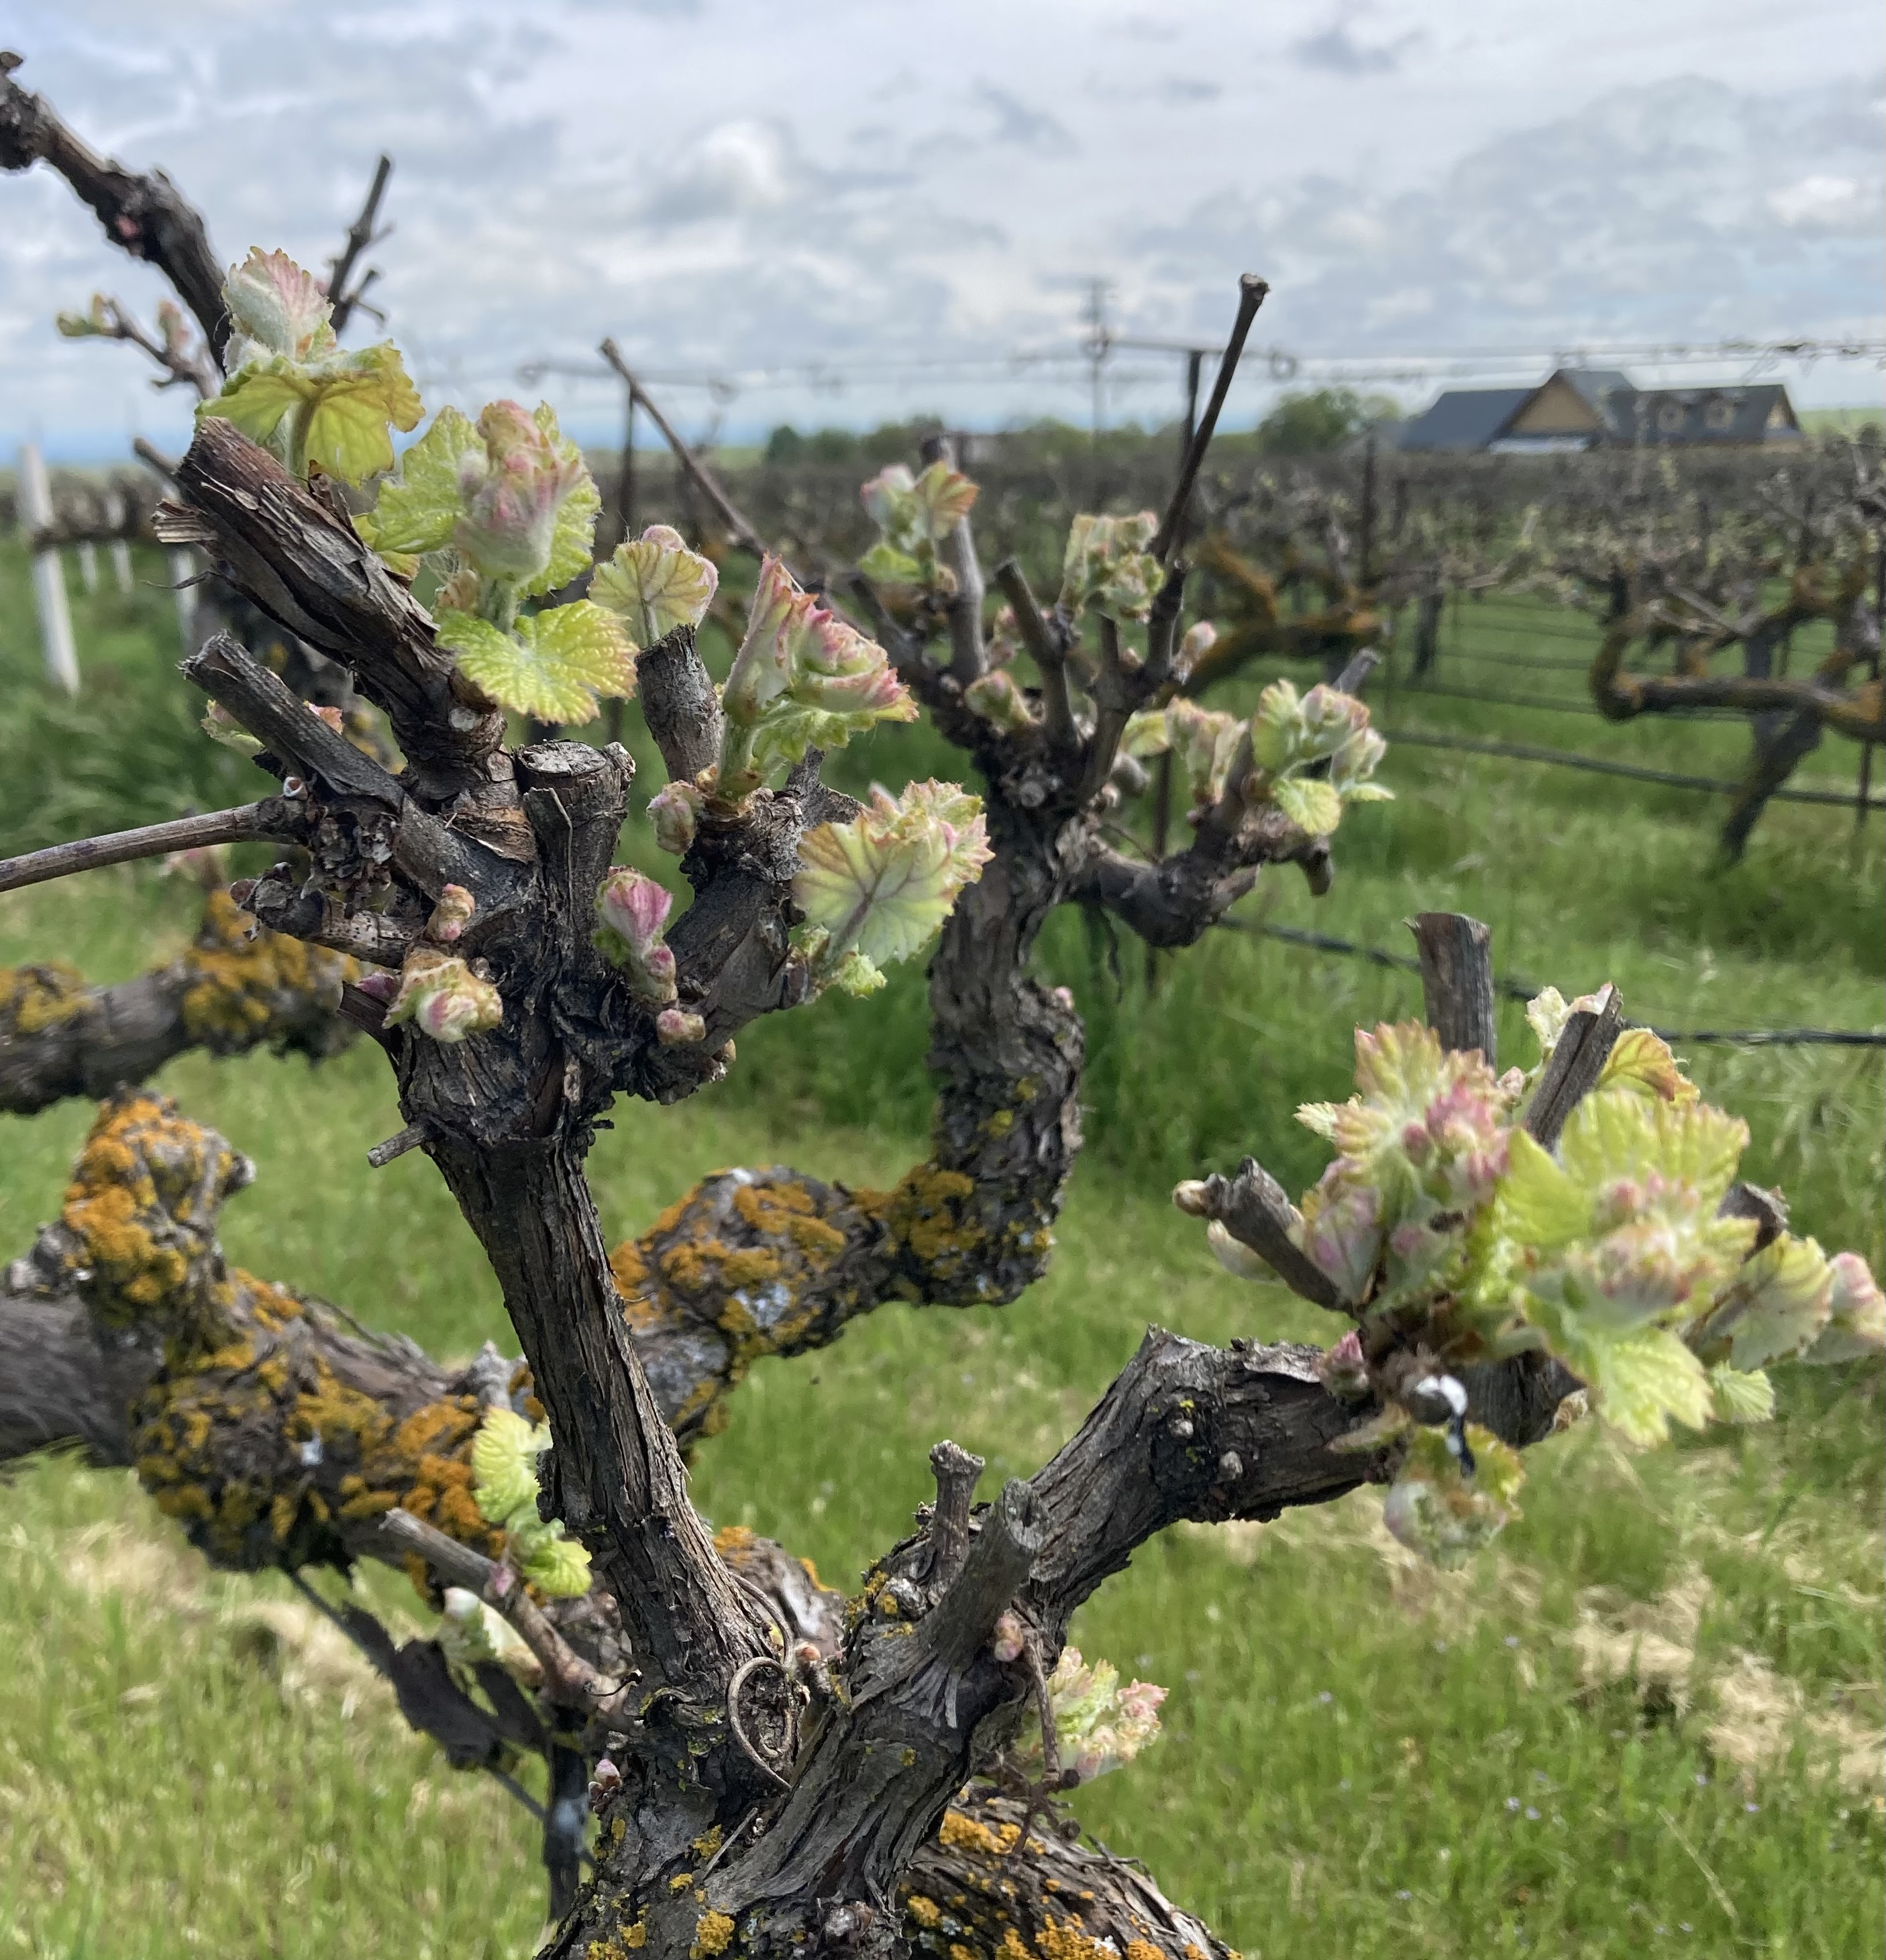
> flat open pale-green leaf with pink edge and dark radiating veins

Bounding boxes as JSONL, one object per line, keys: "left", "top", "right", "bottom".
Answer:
{"left": 792, "top": 782, "right": 992, "bottom": 980}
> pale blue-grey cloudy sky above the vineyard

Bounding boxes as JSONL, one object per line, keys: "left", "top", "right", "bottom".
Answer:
{"left": 0, "top": 0, "right": 1886, "bottom": 457}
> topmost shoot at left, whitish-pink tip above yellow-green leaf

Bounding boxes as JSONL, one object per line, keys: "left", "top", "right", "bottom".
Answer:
{"left": 198, "top": 249, "right": 419, "bottom": 484}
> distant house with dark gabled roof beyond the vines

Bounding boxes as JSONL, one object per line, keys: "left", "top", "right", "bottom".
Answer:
{"left": 1400, "top": 368, "right": 1803, "bottom": 455}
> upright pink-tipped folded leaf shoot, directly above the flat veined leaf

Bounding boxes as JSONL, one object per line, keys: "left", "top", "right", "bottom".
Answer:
{"left": 717, "top": 557, "right": 918, "bottom": 798}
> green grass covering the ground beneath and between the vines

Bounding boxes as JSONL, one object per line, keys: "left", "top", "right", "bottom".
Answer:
{"left": 0, "top": 560, "right": 1886, "bottom": 1960}
